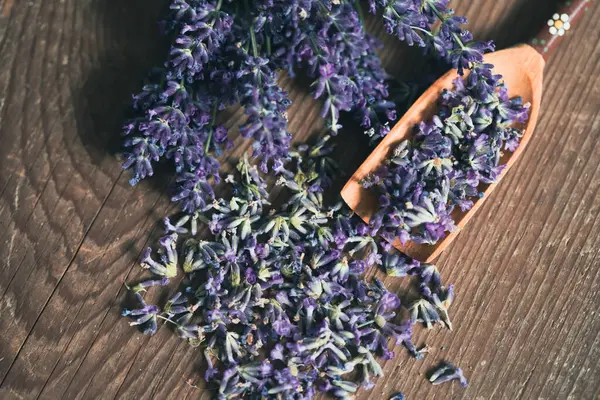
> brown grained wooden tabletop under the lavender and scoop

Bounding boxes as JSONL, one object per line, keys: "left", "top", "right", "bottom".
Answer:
{"left": 0, "top": 0, "right": 600, "bottom": 400}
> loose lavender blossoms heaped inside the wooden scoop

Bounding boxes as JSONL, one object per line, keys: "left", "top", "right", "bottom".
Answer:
{"left": 363, "top": 8, "right": 529, "bottom": 244}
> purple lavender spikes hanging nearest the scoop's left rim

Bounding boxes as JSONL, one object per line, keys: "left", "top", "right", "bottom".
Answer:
{"left": 280, "top": 0, "right": 396, "bottom": 138}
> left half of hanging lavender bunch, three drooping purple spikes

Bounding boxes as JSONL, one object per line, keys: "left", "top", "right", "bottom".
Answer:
{"left": 123, "top": 0, "right": 291, "bottom": 214}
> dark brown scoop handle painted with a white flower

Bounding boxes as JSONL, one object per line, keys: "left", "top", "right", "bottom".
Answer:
{"left": 531, "top": 0, "right": 593, "bottom": 61}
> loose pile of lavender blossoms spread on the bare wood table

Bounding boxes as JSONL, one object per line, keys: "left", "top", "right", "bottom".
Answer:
{"left": 123, "top": 137, "right": 452, "bottom": 399}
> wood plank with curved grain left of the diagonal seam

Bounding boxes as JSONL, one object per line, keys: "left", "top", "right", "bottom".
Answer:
{"left": 0, "top": 2, "right": 172, "bottom": 394}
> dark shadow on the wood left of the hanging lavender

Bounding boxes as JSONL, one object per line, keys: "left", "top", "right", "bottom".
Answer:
{"left": 71, "top": 0, "right": 169, "bottom": 172}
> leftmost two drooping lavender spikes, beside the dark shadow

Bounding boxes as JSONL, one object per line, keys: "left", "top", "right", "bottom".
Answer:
{"left": 123, "top": 0, "right": 233, "bottom": 212}
